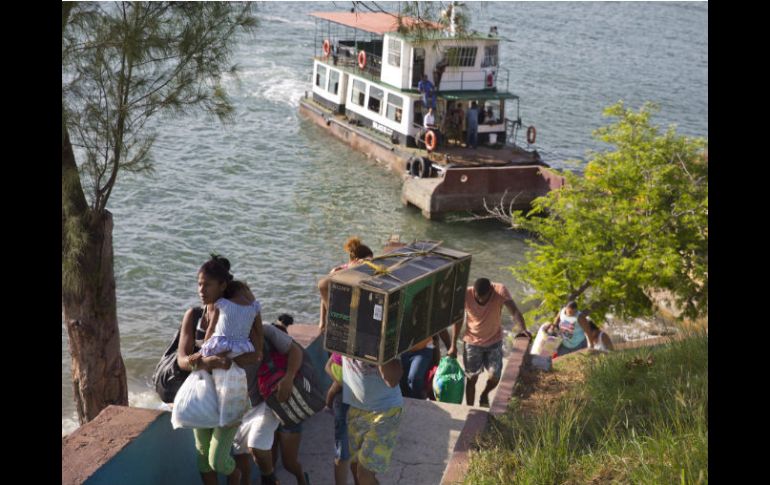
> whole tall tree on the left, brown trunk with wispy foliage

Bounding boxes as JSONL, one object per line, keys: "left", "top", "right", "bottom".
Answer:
{"left": 62, "top": 2, "right": 256, "bottom": 424}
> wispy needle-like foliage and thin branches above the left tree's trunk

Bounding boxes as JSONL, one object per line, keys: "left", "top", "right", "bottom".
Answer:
{"left": 62, "top": 2, "right": 256, "bottom": 212}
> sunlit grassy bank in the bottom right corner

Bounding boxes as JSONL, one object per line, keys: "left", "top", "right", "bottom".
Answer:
{"left": 465, "top": 333, "right": 708, "bottom": 485}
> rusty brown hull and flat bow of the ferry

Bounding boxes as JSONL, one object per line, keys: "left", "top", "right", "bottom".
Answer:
{"left": 299, "top": 96, "right": 564, "bottom": 219}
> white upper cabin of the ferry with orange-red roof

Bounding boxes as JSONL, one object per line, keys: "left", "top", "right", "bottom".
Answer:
{"left": 311, "top": 12, "right": 521, "bottom": 146}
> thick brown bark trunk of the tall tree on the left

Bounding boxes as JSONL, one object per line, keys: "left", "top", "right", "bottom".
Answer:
{"left": 62, "top": 210, "right": 128, "bottom": 424}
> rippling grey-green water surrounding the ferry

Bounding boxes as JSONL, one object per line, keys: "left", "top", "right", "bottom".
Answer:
{"left": 62, "top": 2, "right": 708, "bottom": 434}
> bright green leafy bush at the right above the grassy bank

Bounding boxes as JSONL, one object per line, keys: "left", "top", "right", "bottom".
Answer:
{"left": 511, "top": 102, "right": 708, "bottom": 319}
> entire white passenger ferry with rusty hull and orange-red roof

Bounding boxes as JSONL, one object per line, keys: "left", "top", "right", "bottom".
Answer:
{"left": 300, "top": 12, "right": 564, "bottom": 219}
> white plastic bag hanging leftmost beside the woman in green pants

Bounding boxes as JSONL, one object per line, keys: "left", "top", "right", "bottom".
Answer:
{"left": 171, "top": 370, "right": 219, "bottom": 429}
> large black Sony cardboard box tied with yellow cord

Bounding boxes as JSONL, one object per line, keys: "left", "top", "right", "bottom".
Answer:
{"left": 324, "top": 241, "right": 471, "bottom": 364}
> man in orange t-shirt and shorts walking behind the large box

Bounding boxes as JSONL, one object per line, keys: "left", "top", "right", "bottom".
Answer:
{"left": 447, "top": 278, "right": 527, "bottom": 407}
